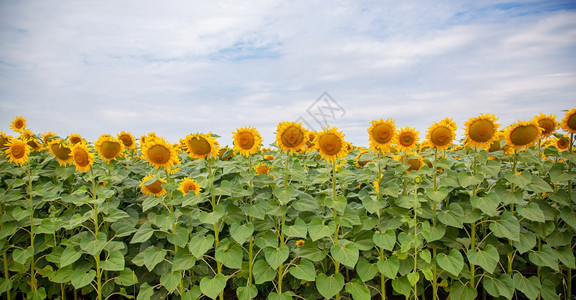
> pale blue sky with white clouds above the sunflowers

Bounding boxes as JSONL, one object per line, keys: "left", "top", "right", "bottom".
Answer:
{"left": 0, "top": 0, "right": 576, "bottom": 145}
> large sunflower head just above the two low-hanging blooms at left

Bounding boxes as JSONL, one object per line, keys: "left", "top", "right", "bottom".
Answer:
{"left": 141, "top": 137, "right": 180, "bottom": 168}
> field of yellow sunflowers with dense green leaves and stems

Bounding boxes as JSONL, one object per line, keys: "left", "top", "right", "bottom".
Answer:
{"left": 0, "top": 108, "right": 576, "bottom": 300}
